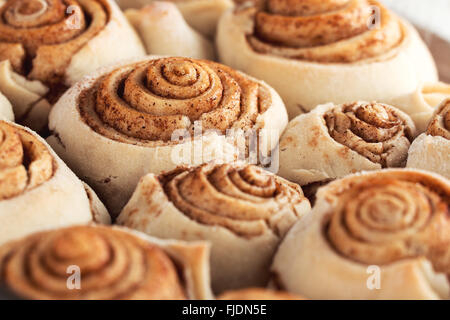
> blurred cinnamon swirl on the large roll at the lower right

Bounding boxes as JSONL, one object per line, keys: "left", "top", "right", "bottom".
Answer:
{"left": 326, "top": 171, "right": 450, "bottom": 266}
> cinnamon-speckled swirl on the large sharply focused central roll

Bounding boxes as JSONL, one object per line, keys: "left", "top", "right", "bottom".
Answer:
{"left": 79, "top": 58, "right": 271, "bottom": 143}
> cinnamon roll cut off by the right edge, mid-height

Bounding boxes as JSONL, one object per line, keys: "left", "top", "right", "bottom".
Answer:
{"left": 407, "top": 98, "right": 450, "bottom": 179}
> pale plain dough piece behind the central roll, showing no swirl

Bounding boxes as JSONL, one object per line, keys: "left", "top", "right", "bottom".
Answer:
{"left": 125, "top": 2, "right": 216, "bottom": 60}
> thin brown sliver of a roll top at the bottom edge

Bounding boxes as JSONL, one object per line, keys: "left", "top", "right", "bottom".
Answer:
{"left": 218, "top": 288, "right": 304, "bottom": 300}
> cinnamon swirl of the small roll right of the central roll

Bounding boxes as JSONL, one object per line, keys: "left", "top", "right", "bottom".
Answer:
{"left": 324, "top": 102, "right": 414, "bottom": 168}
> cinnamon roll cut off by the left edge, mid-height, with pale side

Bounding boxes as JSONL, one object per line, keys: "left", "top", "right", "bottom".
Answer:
{"left": 0, "top": 120, "right": 110, "bottom": 243}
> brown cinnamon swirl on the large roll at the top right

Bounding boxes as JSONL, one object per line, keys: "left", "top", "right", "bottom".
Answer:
{"left": 244, "top": 0, "right": 403, "bottom": 63}
